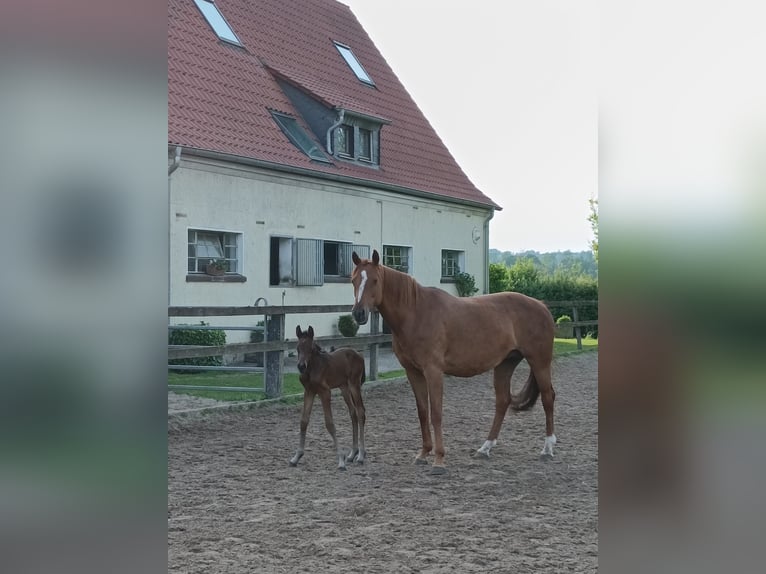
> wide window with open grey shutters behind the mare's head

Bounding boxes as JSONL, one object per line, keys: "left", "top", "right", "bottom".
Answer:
{"left": 269, "top": 237, "right": 370, "bottom": 287}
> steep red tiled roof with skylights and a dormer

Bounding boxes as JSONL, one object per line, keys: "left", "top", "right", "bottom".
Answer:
{"left": 168, "top": 0, "right": 499, "bottom": 209}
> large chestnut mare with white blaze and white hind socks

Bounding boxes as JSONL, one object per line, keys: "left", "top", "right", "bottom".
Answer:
{"left": 351, "top": 251, "right": 556, "bottom": 474}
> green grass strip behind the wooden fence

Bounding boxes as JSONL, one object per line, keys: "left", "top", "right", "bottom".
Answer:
{"left": 168, "top": 339, "right": 598, "bottom": 402}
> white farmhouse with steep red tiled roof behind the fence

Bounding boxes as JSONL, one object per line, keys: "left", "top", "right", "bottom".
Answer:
{"left": 168, "top": 0, "right": 500, "bottom": 341}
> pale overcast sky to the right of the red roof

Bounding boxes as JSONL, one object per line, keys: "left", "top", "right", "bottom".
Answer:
{"left": 341, "top": 0, "right": 598, "bottom": 252}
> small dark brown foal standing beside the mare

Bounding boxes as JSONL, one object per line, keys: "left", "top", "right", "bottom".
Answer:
{"left": 290, "top": 325, "right": 366, "bottom": 470}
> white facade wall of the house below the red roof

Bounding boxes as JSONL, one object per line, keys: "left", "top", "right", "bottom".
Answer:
{"left": 169, "top": 155, "right": 492, "bottom": 342}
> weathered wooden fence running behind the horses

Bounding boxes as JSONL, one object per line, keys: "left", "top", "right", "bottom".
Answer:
{"left": 168, "top": 301, "right": 598, "bottom": 398}
